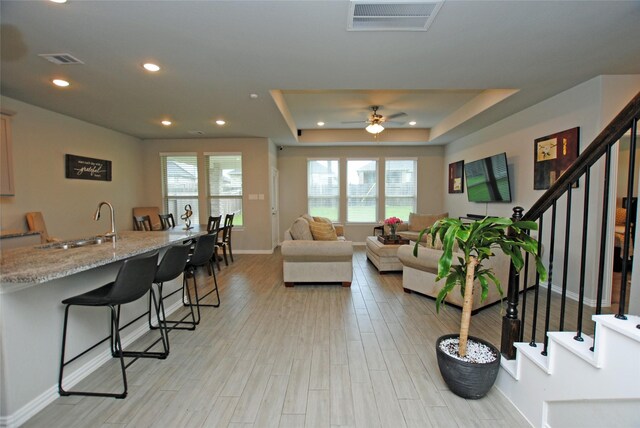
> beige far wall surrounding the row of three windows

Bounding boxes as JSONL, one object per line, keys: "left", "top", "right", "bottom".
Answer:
{"left": 278, "top": 146, "right": 445, "bottom": 242}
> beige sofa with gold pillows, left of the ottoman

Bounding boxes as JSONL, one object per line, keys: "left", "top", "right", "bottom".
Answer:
{"left": 281, "top": 214, "right": 353, "bottom": 287}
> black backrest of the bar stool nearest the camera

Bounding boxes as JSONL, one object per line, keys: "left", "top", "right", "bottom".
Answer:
{"left": 108, "top": 251, "right": 158, "bottom": 305}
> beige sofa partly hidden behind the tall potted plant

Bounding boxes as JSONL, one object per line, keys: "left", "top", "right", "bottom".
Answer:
{"left": 398, "top": 245, "right": 535, "bottom": 312}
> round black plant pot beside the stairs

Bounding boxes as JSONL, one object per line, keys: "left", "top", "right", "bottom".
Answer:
{"left": 436, "top": 334, "right": 500, "bottom": 400}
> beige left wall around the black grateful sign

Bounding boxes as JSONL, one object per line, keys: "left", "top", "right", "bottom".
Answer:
{"left": 0, "top": 96, "right": 144, "bottom": 244}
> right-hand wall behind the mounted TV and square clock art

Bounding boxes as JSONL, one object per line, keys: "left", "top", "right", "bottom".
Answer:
{"left": 444, "top": 76, "right": 640, "bottom": 310}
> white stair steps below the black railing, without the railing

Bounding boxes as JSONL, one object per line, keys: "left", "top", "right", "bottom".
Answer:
{"left": 496, "top": 315, "right": 640, "bottom": 428}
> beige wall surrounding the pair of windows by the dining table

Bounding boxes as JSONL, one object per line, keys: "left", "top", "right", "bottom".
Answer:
{"left": 142, "top": 138, "right": 273, "bottom": 252}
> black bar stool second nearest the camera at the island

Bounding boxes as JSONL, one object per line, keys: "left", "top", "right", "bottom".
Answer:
{"left": 149, "top": 244, "right": 196, "bottom": 340}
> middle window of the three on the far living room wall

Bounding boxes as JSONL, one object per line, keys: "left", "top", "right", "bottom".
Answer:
{"left": 347, "top": 159, "right": 378, "bottom": 223}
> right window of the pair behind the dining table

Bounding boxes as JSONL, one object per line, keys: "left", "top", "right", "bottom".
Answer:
{"left": 205, "top": 153, "right": 243, "bottom": 226}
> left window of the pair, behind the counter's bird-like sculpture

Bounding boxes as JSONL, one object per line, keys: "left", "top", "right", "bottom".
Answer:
{"left": 160, "top": 153, "right": 199, "bottom": 224}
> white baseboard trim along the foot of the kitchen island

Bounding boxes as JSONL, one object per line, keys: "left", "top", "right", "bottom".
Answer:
{"left": 0, "top": 300, "right": 182, "bottom": 428}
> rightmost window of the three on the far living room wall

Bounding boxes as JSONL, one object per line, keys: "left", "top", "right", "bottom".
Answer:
{"left": 384, "top": 159, "right": 418, "bottom": 221}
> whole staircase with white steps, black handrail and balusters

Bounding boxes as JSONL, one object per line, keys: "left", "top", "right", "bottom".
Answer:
{"left": 496, "top": 93, "right": 640, "bottom": 428}
